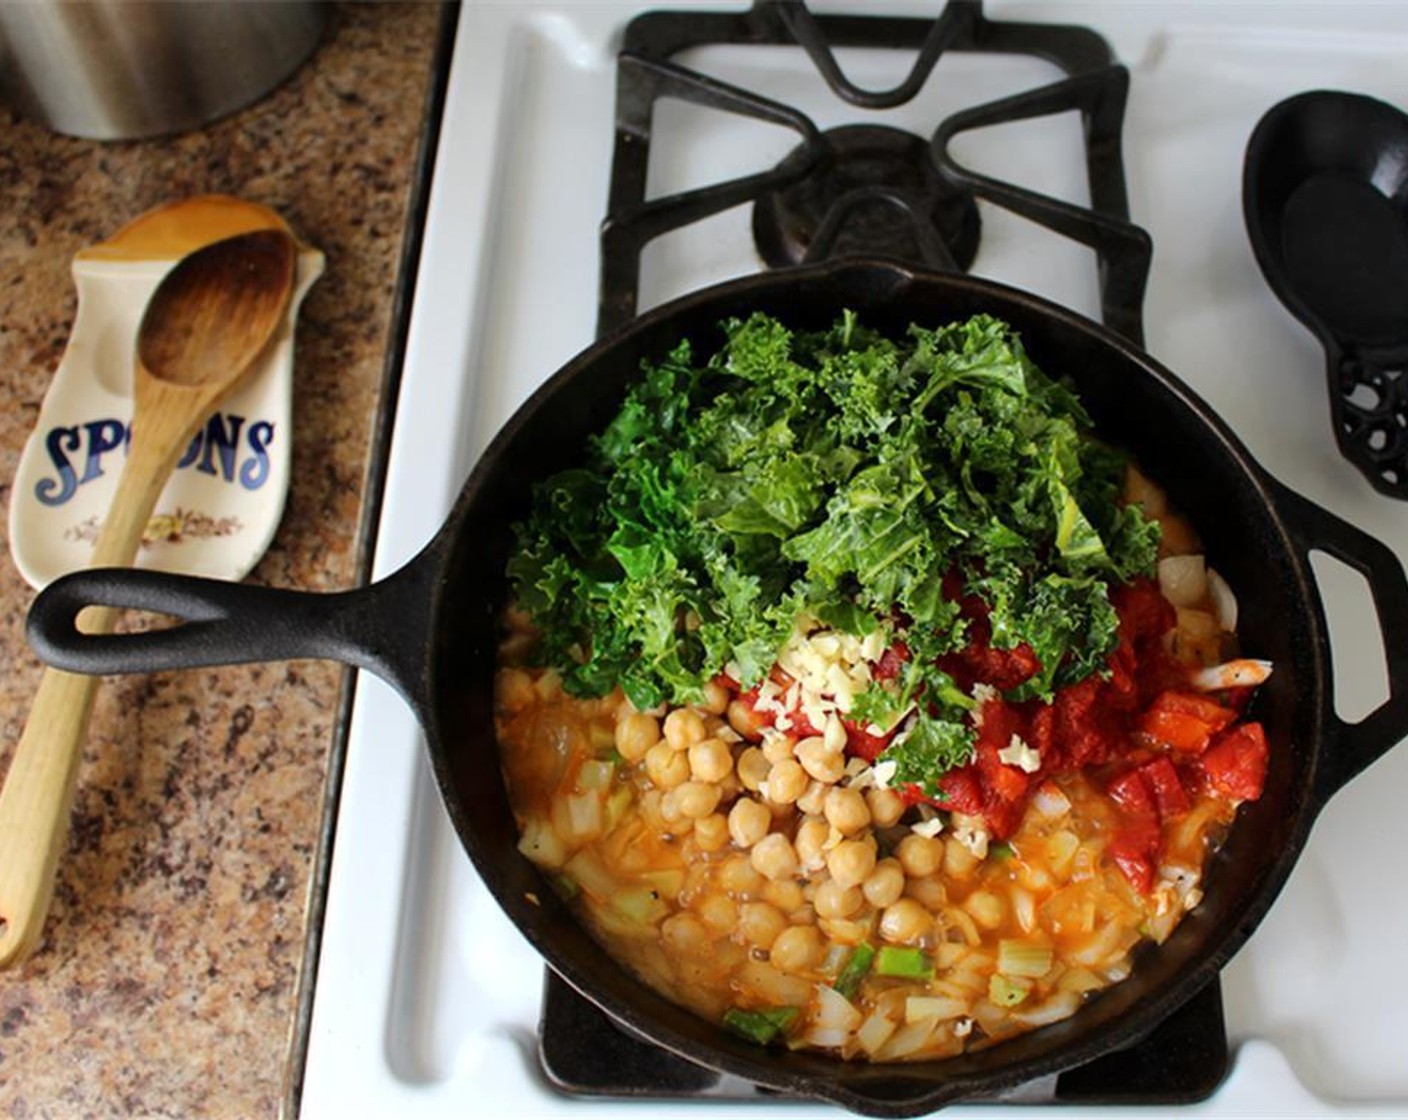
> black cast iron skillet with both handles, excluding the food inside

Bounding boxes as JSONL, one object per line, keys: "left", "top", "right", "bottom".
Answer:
{"left": 30, "top": 258, "right": 1408, "bottom": 1116}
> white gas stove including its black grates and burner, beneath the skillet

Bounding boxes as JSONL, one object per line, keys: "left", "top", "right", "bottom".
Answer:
{"left": 301, "top": 0, "right": 1408, "bottom": 1117}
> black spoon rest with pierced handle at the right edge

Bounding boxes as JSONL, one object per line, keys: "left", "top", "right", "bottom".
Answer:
{"left": 1242, "top": 90, "right": 1408, "bottom": 499}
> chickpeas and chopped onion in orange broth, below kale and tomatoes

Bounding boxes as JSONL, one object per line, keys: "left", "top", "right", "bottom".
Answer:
{"left": 498, "top": 648, "right": 1229, "bottom": 1062}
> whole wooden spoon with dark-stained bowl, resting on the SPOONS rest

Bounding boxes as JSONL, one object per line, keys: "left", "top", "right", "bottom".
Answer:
{"left": 0, "top": 230, "right": 297, "bottom": 968}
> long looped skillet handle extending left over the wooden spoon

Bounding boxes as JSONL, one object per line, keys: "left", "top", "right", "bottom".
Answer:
{"left": 27, "top": 548, "right": 438, "bottom": 713}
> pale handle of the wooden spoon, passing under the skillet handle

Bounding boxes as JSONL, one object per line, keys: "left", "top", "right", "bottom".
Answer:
{"left": 0, "top": 393, "right": 194, "bottom": 969}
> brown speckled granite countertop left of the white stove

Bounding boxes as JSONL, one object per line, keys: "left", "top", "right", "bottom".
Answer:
{"left": 0, "top": 3, "right": 439, "bottom": 1120}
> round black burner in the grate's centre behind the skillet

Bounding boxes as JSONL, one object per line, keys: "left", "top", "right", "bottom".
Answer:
{"left": 753, "top": 124, "right": 979, "bottom": 272}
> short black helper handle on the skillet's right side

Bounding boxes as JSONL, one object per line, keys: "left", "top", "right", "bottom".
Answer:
{"left": 1273, "top": 483, "right": 1408, "bottom": 803}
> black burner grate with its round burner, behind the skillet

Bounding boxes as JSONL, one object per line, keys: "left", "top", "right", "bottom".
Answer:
{"left": 597, "top": 0, "right": 1152, "bottom": 344}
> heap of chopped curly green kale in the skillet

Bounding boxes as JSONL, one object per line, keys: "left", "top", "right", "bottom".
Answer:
{"left": 508, "top": 313, "right": 1159, "bottom": 788}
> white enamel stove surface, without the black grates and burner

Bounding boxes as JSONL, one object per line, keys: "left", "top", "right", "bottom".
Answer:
{"left": 301, "top": 0, "right": 1408, "bottom": 1120}
